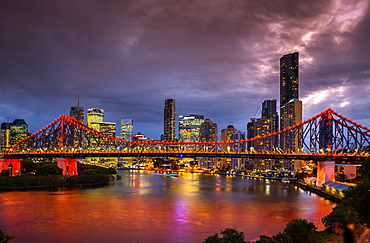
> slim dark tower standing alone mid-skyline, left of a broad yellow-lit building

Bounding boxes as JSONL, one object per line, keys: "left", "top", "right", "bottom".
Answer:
{"left": 163, "top": 99, "right": 176, "bottom": 141}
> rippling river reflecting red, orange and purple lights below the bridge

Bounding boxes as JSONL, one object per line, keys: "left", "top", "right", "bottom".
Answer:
{"left": 0, "top": 171, "right": 335, "bottom": 243}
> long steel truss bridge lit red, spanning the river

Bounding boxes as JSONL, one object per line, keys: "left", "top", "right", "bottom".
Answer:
{"left": 0, "top": 109, "right": 370, "bottom": 178}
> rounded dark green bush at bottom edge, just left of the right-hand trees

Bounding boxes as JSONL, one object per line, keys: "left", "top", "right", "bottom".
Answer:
{"left": 284, "top": 219, "right": 317, "bottom": 243}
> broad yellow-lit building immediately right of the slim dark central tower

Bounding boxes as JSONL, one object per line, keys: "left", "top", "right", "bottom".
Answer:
{"left": 179, "top": 114, "right": 204, "bottom": 142}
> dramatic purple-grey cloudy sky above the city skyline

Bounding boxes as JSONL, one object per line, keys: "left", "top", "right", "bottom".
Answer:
{"left": 0, "top": 0, "right": 370, "bottom": 139}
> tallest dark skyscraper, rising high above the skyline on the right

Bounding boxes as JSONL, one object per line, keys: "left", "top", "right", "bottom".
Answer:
{"left": 280, "top": 52, "right": 299, "bottom": 107}
